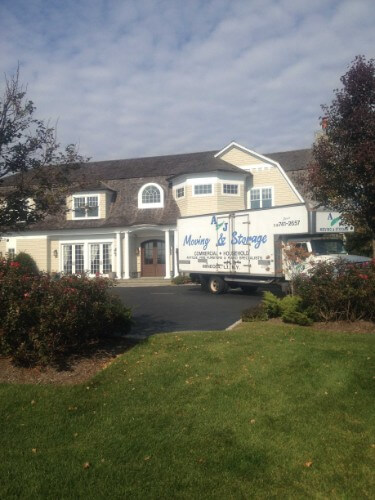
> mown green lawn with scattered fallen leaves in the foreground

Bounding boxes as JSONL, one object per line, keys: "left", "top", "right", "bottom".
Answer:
{"left": 0, "top": 323, "right": 375, "bottom": 499}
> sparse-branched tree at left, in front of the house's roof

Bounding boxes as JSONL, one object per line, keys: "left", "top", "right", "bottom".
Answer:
{"left": 0, "top": 69, "right": 86, "bottom": 234}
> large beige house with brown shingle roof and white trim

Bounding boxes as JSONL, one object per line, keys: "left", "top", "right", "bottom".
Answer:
{"left": 0, "top": 142, "right": 310, "bottom": 279}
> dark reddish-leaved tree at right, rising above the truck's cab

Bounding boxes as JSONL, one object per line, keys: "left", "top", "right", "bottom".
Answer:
{"left": 307, "top": 56, "right": 375, "bottom": 237}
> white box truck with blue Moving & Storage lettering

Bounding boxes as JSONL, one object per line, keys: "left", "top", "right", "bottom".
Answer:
{"left": 177, "top": 204, "right": 368, "bottom": 294}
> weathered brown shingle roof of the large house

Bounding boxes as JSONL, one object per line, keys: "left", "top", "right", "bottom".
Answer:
{"left": 3, "top": 145, "right": 311, "bottom": 230}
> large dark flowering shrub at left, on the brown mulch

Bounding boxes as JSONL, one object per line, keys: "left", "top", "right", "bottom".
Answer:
{"left": 0, "top": 261, "right": 131, "bottom": 365}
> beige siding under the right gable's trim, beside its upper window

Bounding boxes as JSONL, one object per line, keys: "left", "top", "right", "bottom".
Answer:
{"left": 251, "top": 167, "right": 300, "bottom": 206}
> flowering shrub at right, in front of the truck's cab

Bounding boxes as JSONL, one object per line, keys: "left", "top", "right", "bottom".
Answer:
{"left": 294, "top": 260, "right": 375, "bottom": 321}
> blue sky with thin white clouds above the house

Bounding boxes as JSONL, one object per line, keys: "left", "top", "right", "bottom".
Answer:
{"left": 0, "top": 0, "right": 375, "bottom": 160}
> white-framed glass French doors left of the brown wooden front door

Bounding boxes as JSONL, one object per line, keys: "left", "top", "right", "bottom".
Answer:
{"left": 62, "top": 243, "right": 112, "bottom": 275}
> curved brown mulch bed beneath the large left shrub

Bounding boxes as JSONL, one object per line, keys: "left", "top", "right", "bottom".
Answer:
{"left": 0, "top": 338, "right": 134, "bottom": 385}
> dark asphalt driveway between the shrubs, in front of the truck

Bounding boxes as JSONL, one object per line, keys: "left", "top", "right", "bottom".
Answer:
{"left": 114, "top": 285, "right": 262, "bottom": 335}
